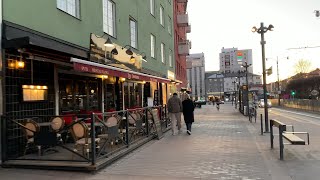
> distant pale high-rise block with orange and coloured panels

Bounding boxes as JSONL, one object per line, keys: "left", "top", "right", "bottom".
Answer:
{"left": 219, "top": 48, "right": 253, "bottom": 74}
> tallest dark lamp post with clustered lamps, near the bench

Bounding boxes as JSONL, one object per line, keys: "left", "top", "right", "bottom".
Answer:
{"left": 251, "top": 22, "right": 274, "bottom": 132}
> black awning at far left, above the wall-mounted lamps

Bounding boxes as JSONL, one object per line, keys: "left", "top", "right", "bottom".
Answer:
{"left": 2, "top": 21, "right": 88, "bottom": 58}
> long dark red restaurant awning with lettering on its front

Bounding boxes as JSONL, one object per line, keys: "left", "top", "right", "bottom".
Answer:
{"left": 71, "top": 58, "right": 170, "bottom": 83}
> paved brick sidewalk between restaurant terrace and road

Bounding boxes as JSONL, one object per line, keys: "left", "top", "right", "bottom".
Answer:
{"left": 0, "top": 104, "right": 320, "bottom": 180}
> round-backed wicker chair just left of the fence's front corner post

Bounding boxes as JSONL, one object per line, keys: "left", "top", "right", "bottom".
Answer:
{"left": 71, "top": 121, "right": 100, "bottom": 158}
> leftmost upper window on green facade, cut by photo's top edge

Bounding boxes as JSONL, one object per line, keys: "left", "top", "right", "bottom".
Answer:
{"left": 57, "top": 0, "right": 80, "bottom": 18}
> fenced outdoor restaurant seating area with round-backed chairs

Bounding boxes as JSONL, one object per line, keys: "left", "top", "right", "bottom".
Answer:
{"left": 3, "top": 106, "right": 170, "bottom": 170}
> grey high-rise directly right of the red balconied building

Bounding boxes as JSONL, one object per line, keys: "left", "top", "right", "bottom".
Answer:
{"left": 187, "top": 53, "right": 206, "bottom": 100}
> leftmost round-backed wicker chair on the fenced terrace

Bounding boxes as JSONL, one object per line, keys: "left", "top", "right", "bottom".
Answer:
{"left": 21, "top": 119, "right": 41, "bottom": 156}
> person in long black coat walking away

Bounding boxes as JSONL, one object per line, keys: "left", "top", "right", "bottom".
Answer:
{"left": 182, "top": 97, "right": 194, "bottom": 135}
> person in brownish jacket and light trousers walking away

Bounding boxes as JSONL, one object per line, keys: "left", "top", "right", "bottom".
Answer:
{"left": 167, "top": 93, "right": 182, "bottom": 135}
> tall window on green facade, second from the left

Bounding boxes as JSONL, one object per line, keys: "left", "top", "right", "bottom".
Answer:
{"left": 103, "top": 0, "right": 116, "bottom": 36}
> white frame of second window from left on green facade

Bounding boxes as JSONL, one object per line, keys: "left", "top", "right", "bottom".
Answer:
{"left": 102, "top": 0, "right": 116, "bottom": 37}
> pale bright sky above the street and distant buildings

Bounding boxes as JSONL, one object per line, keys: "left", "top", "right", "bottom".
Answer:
{"left": 187, "top": 0, "right": 320, "bottom": 83}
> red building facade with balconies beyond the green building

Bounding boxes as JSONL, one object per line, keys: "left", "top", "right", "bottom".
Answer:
{"left": 173, "top": 0, "right": 191, "bottom": 90}
